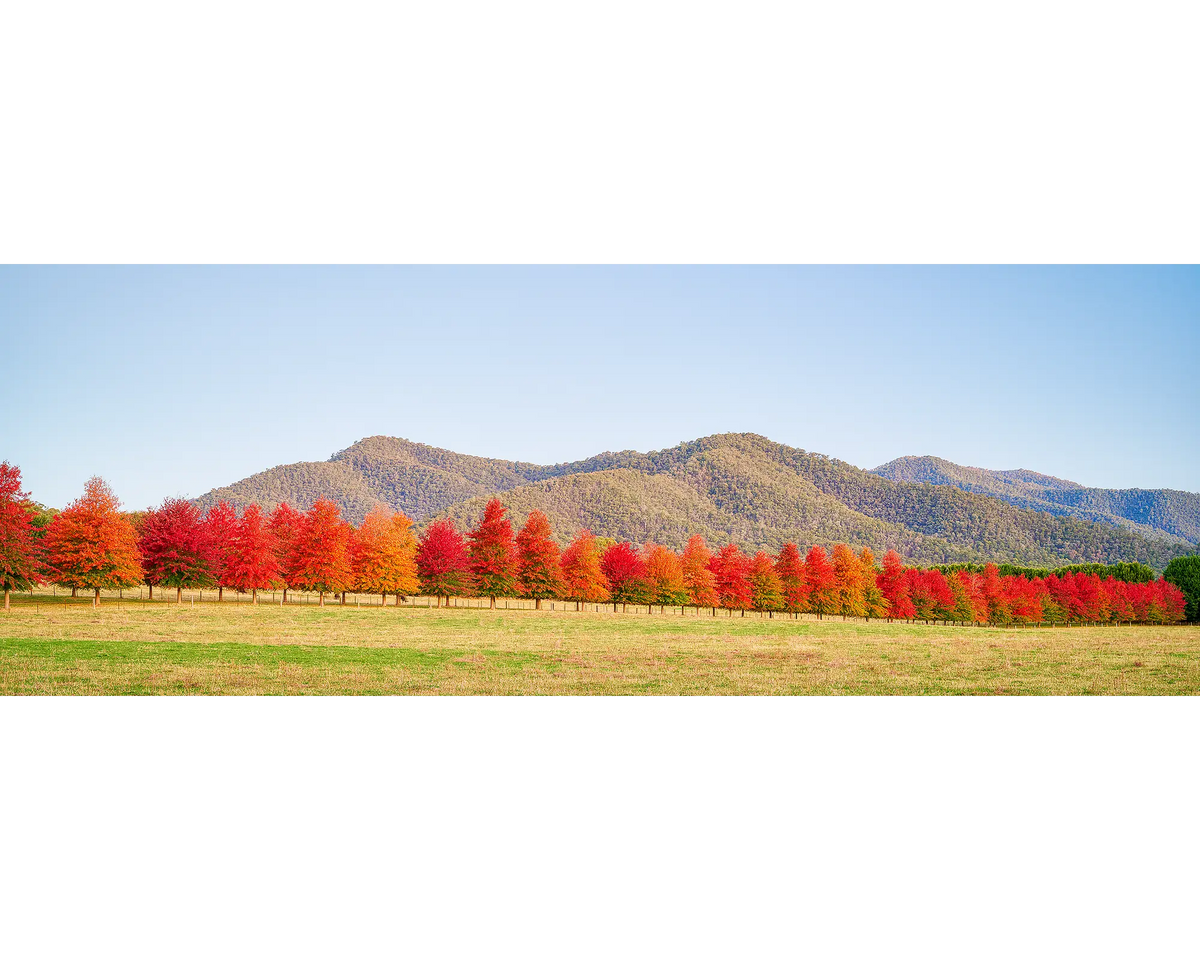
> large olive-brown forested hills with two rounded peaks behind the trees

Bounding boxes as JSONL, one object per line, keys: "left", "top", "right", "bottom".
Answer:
{"left": 198, "top": 433, "right": 1194, "bottom": 570}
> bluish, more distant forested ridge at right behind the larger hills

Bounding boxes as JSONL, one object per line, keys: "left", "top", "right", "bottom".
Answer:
{"left": 870, "top": 457, "right": 1200, "bottom": 544}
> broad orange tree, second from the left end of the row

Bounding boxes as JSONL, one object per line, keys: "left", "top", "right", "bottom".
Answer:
{"left": 42, "top": 476, "right": 142, "bottom": 604}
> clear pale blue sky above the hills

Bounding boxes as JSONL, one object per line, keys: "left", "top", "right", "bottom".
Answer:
{"left": 0, "top": 264, "right": 1200, "bottom": 509}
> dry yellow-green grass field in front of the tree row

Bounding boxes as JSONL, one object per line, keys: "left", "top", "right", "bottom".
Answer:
{"left": 0, "top": 595, "right": 1200, "bottom": 696}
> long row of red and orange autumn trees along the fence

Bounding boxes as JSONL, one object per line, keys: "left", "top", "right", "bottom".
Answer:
{"left": 0, "top": 464, "right": 1184, "bottom": 623}
